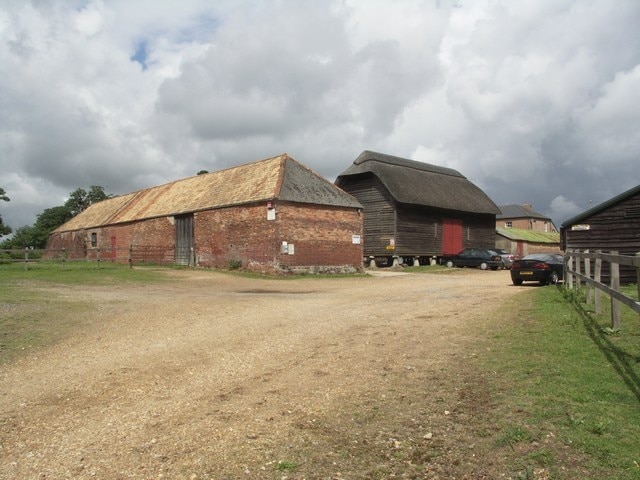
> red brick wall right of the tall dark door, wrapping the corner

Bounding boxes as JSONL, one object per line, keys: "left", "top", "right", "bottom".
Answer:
{"left": 194, "top": 202, "right": 362, "bottom": 271}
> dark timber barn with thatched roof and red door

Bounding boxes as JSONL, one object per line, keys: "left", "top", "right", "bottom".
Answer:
{"left": 335, "top": 150, "right": 500, "bottom": 265}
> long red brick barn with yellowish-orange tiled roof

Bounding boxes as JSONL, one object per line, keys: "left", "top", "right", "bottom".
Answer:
{"left": 47, "top": 154, "right": 363, "bottom": 272}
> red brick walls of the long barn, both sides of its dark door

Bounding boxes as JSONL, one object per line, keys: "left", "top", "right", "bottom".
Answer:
{"left": 48, "top": 202, "right": 363, "bottom": 272}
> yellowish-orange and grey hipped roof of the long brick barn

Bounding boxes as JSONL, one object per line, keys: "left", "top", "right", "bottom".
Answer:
{"left": 55, "top": 153, "right": 362, "bottom": 232}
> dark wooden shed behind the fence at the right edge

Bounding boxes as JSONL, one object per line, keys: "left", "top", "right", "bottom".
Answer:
{"left": 560, "top": 185, "right": 640, "bottom": 283}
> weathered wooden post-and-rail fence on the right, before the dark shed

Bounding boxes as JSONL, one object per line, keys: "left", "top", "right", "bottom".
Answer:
{"left": 564, "top": 250, "right": 640, "bottom": 329}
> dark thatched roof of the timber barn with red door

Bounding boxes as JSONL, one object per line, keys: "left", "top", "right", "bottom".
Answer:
{"left": 336, "top": 150, "right": 500, "bottom": 215}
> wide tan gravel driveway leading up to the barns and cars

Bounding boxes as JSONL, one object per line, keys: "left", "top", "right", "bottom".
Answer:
{"left": 0, "top": 269, "right": 523, "bottom": 479}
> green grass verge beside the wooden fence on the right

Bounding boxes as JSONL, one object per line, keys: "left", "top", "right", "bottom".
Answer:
{"left": 480, "top": 286, "right": 640, "bottom": 480}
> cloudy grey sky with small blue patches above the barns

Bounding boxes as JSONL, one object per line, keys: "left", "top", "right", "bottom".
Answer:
{"left": 0, "top": 0, "right": 640, "bottom": 230}
